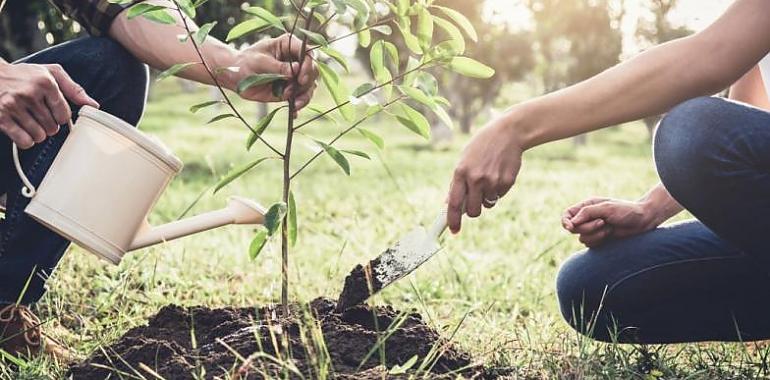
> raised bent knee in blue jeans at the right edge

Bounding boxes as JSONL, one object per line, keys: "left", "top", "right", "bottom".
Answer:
{"left": 654, "top": 98, "right": 770, "bottom": 264}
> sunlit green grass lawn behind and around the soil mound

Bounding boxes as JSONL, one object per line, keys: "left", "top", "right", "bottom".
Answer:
{"left": 6, "top": 82, "right": 768, "bottom": 379}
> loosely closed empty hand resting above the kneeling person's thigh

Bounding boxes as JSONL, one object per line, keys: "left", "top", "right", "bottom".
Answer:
{"left": 561, "top": 198, "right": 661, "bottom": 248}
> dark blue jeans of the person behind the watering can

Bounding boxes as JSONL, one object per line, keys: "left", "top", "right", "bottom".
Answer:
{"left": 0, "top": 38, "right": 148, "bottom": 304}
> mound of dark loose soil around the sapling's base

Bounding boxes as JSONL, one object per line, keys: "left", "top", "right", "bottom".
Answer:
{"left": 70, "top": 299, "right": 486, "bottom": 379}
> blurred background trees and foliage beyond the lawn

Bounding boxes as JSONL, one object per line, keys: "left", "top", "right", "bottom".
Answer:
{"left": 0, "top": 0, "right": 691, "bottom": 137}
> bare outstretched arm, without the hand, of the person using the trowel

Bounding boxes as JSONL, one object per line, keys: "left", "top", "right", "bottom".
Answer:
{"left": 507, "top": 0, "right": 770, "bottom": 148}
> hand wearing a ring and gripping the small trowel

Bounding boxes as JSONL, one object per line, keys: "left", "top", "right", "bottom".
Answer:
{"left": 447, "top": 118, "right": 524, "bottom": 233}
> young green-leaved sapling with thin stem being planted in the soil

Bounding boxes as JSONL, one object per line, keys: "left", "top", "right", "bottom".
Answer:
{"left": 108, "top": 0, "right": 495, "bottom": 312}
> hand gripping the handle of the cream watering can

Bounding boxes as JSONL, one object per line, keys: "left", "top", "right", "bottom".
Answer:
{"left": 0, "top": 60, "right": 99, "bottom": 149}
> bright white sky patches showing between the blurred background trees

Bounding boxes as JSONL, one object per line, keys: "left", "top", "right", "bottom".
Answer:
{"left": 486, "top": 0, "right": 733, "bottom": 53}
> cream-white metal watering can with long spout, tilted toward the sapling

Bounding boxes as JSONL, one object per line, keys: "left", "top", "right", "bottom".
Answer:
{"left": 8, "top": 106, "right": 265, "bottom": 264}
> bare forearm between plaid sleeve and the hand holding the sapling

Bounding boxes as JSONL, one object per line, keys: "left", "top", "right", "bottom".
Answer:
{"left": 109, "top": 0, "right": 238, "bottom": 89}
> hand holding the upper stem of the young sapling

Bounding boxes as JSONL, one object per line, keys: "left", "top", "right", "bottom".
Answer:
{"left": 232, "top": 34, "right": 318, "bottom": 110}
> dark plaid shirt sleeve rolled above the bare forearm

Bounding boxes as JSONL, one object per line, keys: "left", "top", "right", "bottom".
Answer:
{"left": 49, "top": 0, "right": 141, "bottom": 36}
